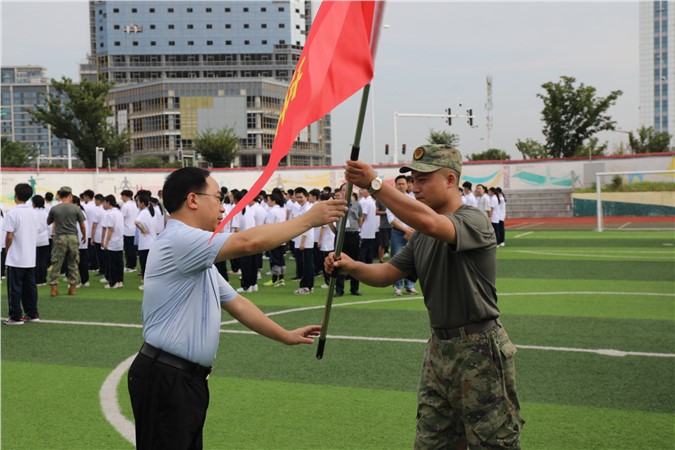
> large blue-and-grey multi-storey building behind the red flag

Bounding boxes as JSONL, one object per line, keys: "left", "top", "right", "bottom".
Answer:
{"left": 89, "top": 0, "right": 331, "bottom": 166}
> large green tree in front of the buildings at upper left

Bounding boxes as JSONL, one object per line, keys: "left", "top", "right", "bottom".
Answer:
{"left": 31, "top": 77, "right": 130, "bottom": 167}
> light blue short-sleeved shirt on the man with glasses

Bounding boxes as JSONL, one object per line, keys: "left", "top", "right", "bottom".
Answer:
{"left": 142, "top": 219, "right": 237, "bottom": 366}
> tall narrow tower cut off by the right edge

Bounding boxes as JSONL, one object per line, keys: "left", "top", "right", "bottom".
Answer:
{"left": 640, "top": 0, "right": 675, "bottom": 137}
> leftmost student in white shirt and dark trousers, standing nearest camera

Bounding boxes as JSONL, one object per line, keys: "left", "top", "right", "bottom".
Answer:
{"left": 2, "top": 183, "right": 40, "bottom": 325}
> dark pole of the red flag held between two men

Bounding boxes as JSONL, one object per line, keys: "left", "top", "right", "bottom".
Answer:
{"left": 316, "top": 83, "right": 370, "bottom": 359}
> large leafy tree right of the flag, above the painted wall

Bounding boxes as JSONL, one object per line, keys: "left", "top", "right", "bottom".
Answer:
{"left": 537, "top": 76, "right": 623, "bottom": 158}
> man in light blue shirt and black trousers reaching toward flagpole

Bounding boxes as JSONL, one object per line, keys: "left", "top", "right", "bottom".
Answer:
{"left": 128, "top": 167, "right": 346, "bottom": 449}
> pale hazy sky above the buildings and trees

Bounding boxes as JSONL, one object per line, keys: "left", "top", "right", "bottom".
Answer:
{"left": 0, "top": 0, "right": 640, "bottom": 165}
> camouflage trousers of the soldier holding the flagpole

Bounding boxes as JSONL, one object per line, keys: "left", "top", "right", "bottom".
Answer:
{"left": 415, "top": 324, "right": 525, "bottom": 449}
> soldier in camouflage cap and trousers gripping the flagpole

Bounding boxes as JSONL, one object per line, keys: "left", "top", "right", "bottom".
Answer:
{"left": 325, "top": 145, "right": 525, "bottom": 449}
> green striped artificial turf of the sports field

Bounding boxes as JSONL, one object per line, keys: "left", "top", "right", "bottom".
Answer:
{"left": 0, "top": 232, "right": 675, "bottom": 449}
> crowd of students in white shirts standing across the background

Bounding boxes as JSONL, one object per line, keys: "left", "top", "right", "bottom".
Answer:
{"left": 0, "top": 175, "right": 506, "bottom": 324}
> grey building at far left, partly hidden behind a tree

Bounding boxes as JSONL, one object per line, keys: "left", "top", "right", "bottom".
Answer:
{"left": 0, "top": 66, "right": 68, "bottom": 162}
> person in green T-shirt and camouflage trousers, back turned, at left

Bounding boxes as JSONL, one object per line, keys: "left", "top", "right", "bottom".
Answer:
{"left": 47, "top": 186, "right": 87, "bottom": 297}
